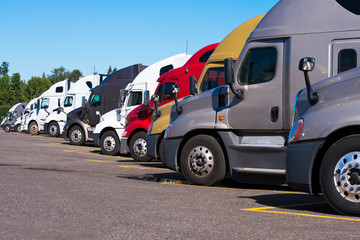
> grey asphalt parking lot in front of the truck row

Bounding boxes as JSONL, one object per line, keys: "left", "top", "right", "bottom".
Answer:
{"left": 0, "top": 130, "right": 360, "bottom": 239}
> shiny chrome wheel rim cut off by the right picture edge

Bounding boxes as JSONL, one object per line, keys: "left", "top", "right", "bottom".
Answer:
{"left": 334, "top": 152, "right": 360, "bottom": 202}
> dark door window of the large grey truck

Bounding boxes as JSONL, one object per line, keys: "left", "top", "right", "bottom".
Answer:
{"left": 239, "top": 47, "right": 277, "bottom": 85}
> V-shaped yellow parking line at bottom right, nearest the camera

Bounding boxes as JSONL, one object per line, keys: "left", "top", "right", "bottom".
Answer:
{"left": 240, "top": 202, "right": 360, "bottom": 222}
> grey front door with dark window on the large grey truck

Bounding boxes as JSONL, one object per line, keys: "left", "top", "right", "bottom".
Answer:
{"left": 217, "top": 41, "right": 284, "bottom": 131}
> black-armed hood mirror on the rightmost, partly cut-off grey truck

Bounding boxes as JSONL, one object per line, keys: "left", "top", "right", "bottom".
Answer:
{"left": 299, "top": 57, "right": 319, "bottom": 105}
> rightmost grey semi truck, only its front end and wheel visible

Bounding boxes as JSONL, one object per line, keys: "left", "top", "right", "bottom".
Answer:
{"left": 286, "top": 59, "right": 360, "bottom": 216}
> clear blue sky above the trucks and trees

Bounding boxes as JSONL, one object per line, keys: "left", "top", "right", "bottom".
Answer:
{"left": 0, "top": 0, "right": 278, "bottom": 81}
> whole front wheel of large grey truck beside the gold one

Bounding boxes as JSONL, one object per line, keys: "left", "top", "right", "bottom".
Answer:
{"left": 180, "top": 135, "right": 226, "bottom": 186}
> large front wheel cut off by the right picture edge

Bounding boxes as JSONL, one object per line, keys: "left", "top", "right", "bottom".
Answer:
{"left": 320, "top": 135, "right": 360, "bottom": 216}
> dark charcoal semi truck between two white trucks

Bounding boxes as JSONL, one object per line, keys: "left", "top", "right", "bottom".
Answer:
{"left": 62, "top": 64, "right": 147, "bottom": 145}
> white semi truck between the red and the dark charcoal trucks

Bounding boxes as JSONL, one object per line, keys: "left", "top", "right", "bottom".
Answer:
{"left": 94, "top": 53, "right": 191, "bottom": 158}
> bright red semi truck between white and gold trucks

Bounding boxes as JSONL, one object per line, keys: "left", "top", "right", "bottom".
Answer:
{"left": 119, "top": 43, "right": 219, "bottom": 161}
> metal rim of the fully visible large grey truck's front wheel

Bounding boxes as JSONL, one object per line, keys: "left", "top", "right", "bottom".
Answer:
{"left": 188, "top": 146, "right": 214, "bottom": 177}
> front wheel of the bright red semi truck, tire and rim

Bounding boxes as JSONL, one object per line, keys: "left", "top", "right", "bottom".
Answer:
{"left": 129, "top": 132, "right": 152, "bottom": 162}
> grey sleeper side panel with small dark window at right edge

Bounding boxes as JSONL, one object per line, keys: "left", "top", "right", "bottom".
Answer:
{"left": 330, "top": 39, "right": 360, "bottom": 76}
